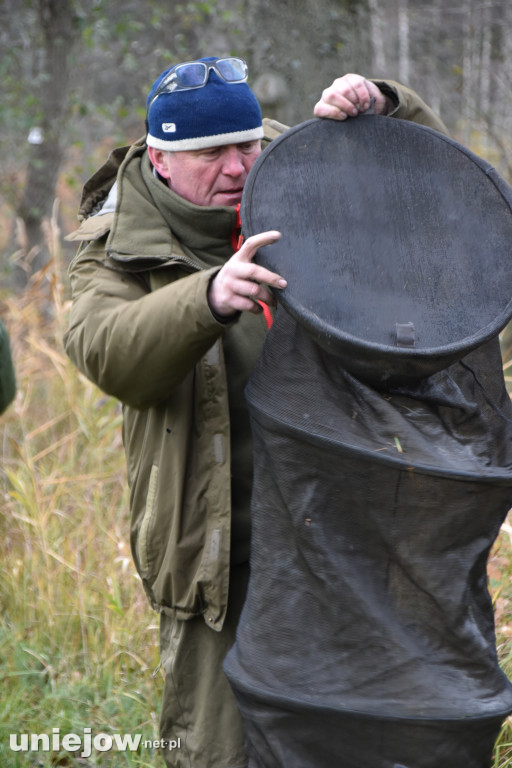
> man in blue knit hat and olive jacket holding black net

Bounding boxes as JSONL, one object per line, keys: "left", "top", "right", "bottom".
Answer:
{"left": 65, "top": 58, "right": 445, "bottom": 768}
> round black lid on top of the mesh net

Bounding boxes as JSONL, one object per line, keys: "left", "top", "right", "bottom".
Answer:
{"left": 242, "top": 115, "right": 512, "bottom": 382}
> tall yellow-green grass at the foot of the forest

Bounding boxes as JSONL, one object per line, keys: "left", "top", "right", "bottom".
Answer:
{"left": 0, "top": 236, "right": 512, "bottom": 768}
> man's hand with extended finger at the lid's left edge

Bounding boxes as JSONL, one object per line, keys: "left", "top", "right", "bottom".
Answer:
{"left": 208, "top": 231, "right": 286, "bottom": 318}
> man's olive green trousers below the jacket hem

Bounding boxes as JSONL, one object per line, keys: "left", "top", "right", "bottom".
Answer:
{"left": 160, "top": 563, "right": 249, "bottom": 768}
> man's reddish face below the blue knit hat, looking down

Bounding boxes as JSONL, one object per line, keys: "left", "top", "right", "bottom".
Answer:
{"left": 151, "top": 140, "right": 261, "bottom": 206}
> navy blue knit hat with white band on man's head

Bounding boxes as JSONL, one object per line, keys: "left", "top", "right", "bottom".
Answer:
{"left": 146, "top": 57, "right": 263, "bottom": 152}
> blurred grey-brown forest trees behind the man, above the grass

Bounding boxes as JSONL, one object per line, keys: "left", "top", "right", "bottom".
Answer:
{"left": 0, "top": 0, "right": 512, "bottom": 283}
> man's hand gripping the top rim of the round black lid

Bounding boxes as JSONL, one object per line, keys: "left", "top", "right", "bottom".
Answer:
{"left": 314, "top": 74, "right": 390, "bottom": 120}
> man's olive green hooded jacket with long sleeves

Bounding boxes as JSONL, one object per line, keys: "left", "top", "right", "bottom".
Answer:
{"left": 65, "top": 83, "right": 445, "bottom": 630}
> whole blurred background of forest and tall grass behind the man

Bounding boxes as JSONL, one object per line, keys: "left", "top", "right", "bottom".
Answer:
{"left": 0, "top": 0, "right": 512, "bottom": 768}
